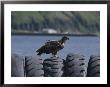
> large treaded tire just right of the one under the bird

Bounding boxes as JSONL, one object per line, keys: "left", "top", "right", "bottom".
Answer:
{"left": 64, "top": 53, "right": 87, "bottom": 77}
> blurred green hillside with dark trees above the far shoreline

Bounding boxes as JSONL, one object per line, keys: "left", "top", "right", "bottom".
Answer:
{"left": 11, "top": 11, "right": 100, "bottom": 34}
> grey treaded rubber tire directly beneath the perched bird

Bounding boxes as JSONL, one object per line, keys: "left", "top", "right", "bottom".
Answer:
{"left": 43, "top": 57, "right": 64, "bottom": 77}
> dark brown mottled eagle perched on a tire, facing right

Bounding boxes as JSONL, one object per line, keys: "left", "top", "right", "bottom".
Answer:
{"left": 36, "top": 36, "right": 69, "bottom": 56}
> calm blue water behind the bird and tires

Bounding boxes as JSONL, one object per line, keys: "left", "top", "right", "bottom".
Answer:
{"left": 11, "top": 35, "right": 100, "bottom": 60}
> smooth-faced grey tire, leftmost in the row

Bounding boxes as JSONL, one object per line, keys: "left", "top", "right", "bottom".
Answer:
{"left": 11, "top": 54, "right": 24, "bottom": 77}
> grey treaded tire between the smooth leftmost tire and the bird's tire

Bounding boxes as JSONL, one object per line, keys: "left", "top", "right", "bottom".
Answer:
{"left": 25, "top": 55, "right": 44, "bottom": 77}
